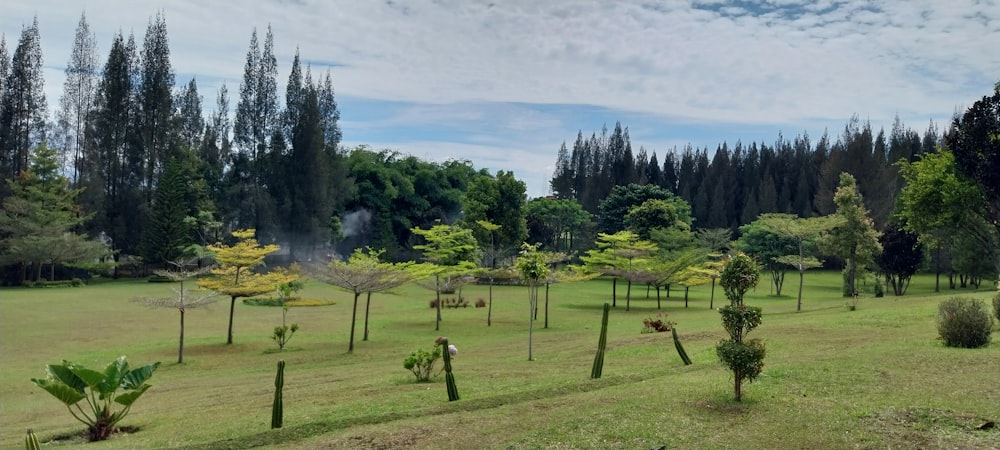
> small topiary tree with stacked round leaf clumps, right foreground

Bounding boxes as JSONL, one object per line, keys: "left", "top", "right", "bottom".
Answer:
{"left": 715, "top": 253, "right": 764, "bottom": 401}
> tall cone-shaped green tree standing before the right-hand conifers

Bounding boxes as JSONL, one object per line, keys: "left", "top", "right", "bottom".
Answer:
{"left": 821, "top": 172, "right": 882, "bottom": 297}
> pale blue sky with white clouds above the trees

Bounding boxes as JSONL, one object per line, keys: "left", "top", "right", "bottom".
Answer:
{"left": 0, "top": 0, "right": 1000, "bottom": 197}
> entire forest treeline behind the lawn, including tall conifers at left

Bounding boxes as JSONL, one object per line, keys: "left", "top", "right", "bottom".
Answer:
{"left": 0, "top": 14, "right": 995, "bottom": 290}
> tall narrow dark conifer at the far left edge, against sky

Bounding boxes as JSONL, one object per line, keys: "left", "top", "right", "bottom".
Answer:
{"left": 0, "top": 17, "right": 48, "bottom": 183}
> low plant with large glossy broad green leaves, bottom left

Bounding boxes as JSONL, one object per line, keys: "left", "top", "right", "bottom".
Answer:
{"left": 31, "top": 356, "right": 160, "bottom": 441}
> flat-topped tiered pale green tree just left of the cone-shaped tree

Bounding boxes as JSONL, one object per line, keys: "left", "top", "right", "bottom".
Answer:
{"left": 757, "top": 213, "right": 838, "bottom": 311}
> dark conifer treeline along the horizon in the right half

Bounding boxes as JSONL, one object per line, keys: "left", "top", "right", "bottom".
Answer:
{"left": 550, "top": 116, "right": 943, "bottom": 233}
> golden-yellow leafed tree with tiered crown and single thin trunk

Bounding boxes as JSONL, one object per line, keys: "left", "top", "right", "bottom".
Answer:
{"left": 198, "top": 229, "right": 299, "bottom": 344}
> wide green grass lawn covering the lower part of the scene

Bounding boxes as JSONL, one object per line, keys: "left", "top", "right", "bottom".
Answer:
{"left": 0, "top": 272, "right": 1000, "bottom": 449}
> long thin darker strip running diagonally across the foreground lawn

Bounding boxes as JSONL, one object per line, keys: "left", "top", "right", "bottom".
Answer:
{"left": 196, "top": 374, "right": 661, "bottom": 450}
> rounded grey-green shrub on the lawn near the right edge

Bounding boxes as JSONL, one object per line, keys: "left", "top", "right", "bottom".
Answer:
{"left": 938, "top": 297, "right": 993, "bottom": 348}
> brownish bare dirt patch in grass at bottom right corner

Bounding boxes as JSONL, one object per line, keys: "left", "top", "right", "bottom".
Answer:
{"left": 863, "top": 408, "right": 1000, "bottom": 449}
